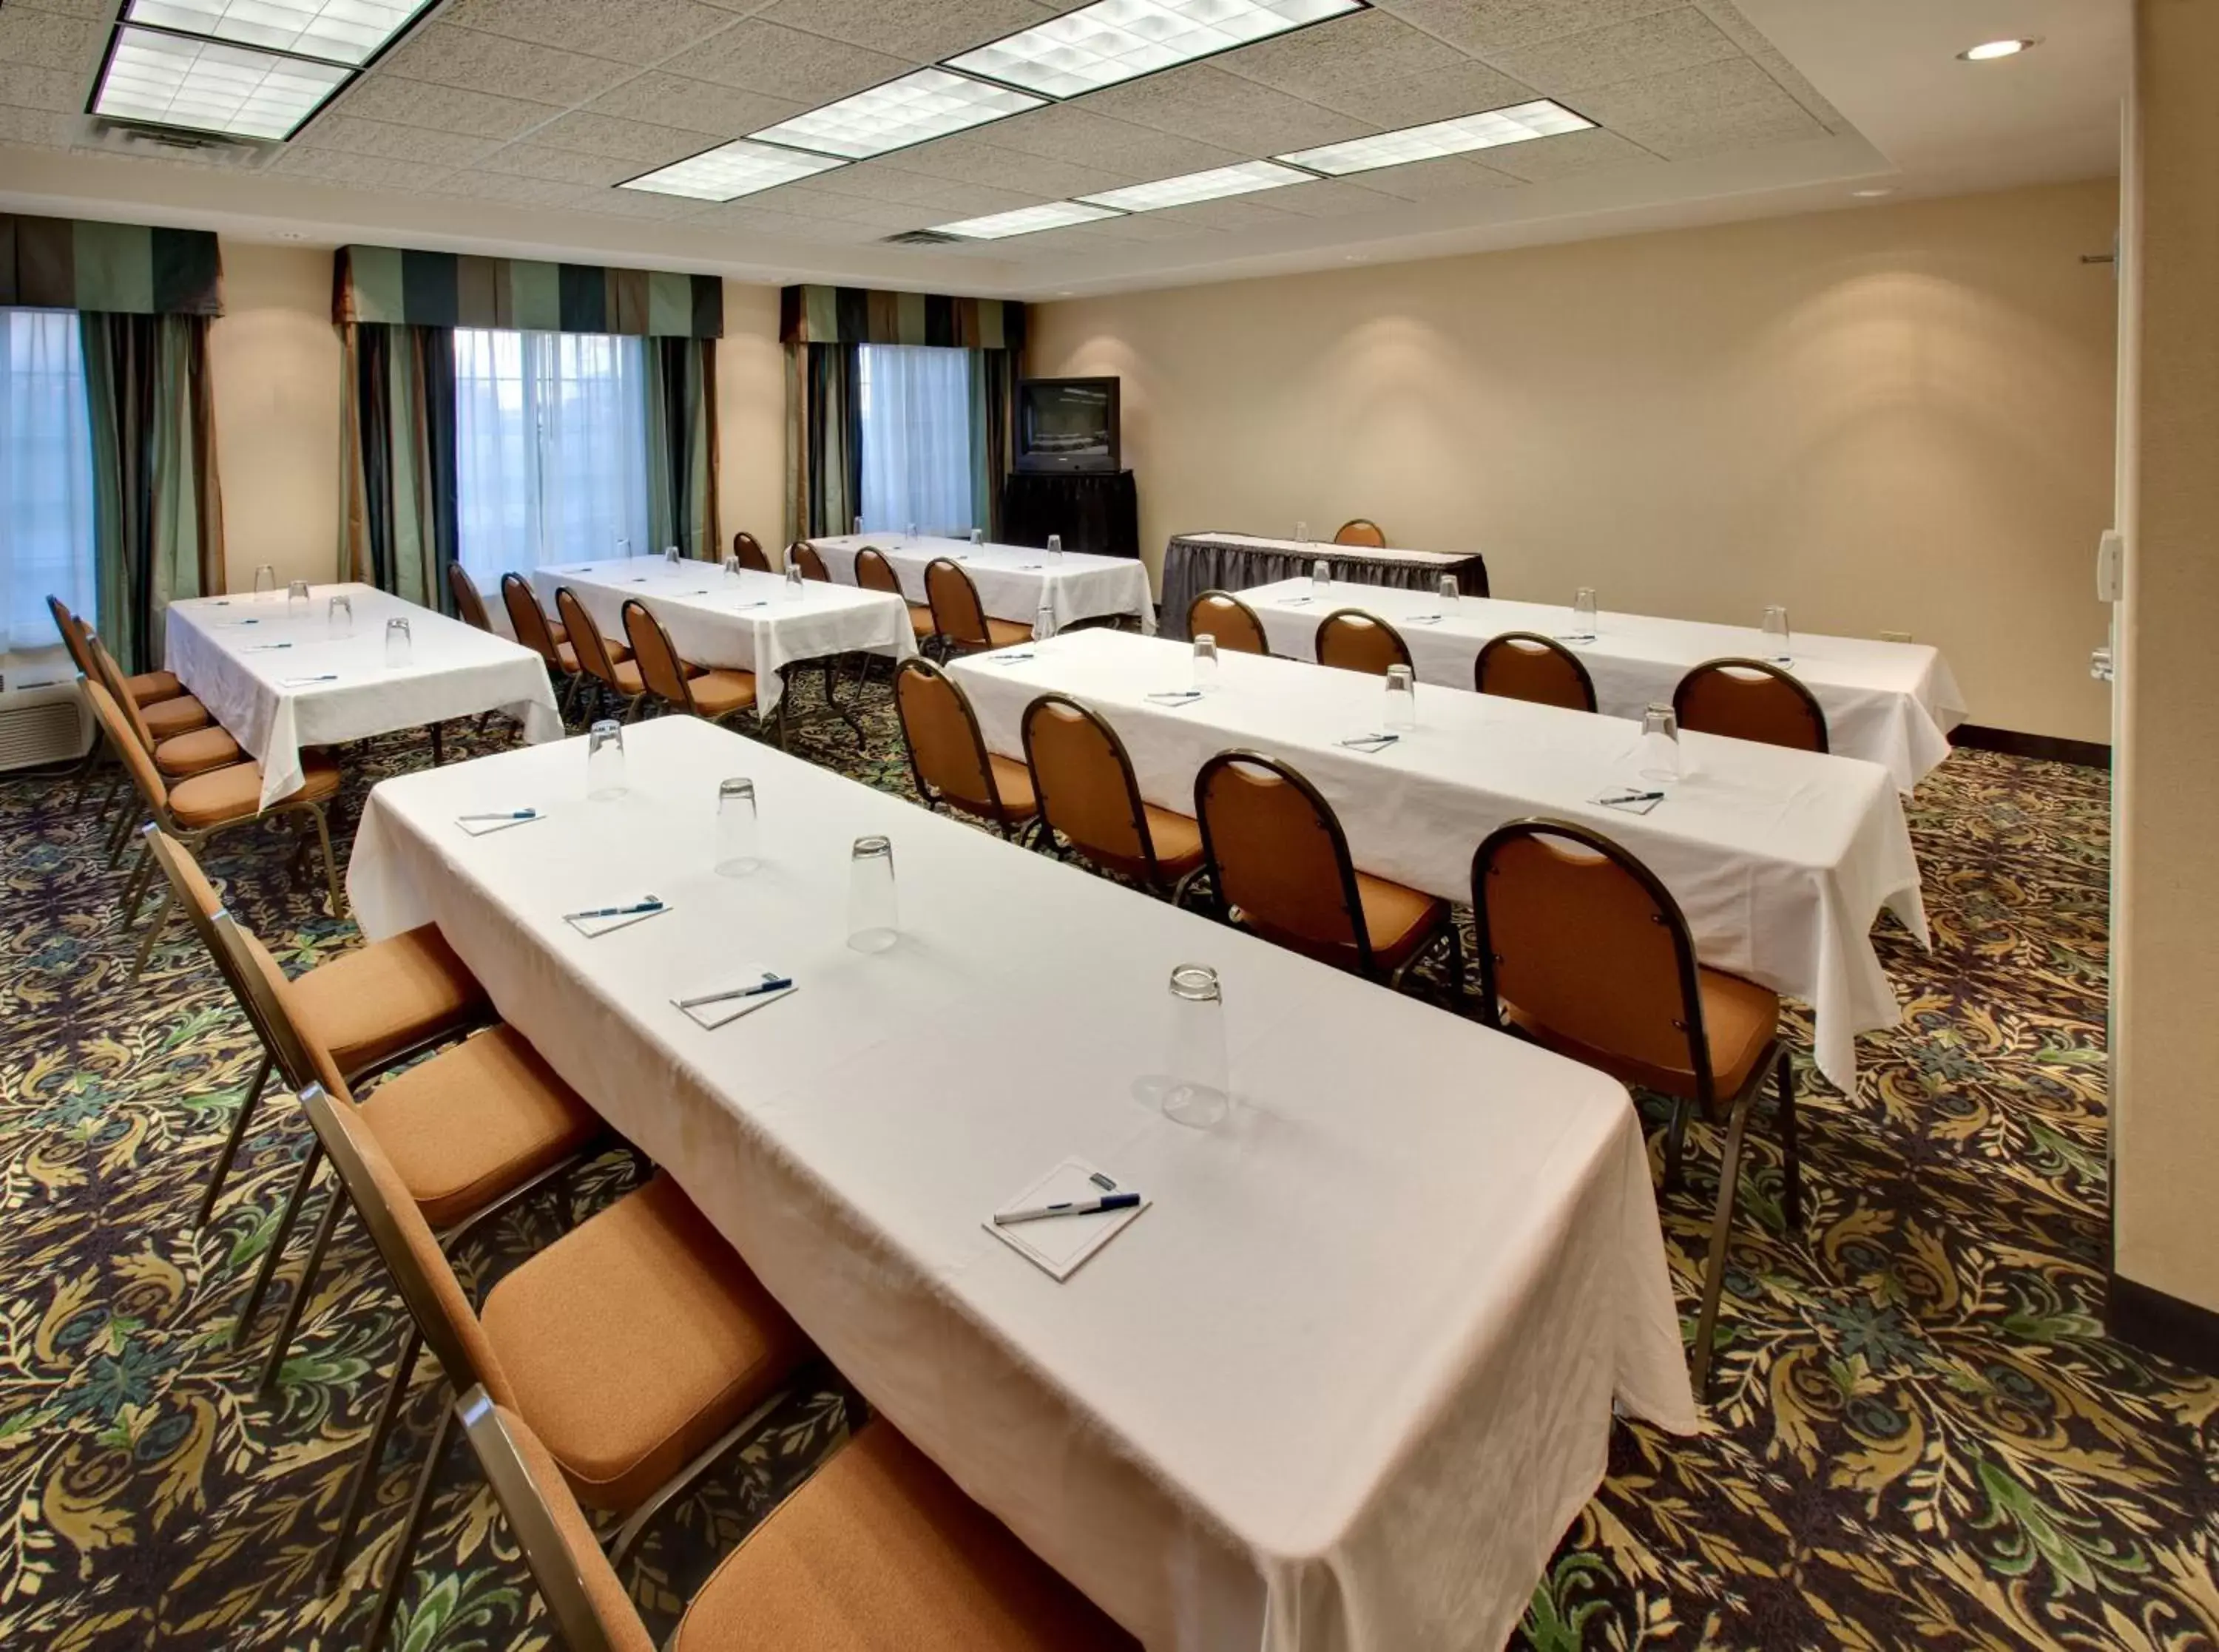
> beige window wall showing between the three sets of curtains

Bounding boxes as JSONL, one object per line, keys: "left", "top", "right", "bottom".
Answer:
{"left": 209, "top": 251, "right": 786, "bottom": 590}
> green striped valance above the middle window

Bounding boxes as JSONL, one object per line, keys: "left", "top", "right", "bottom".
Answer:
{"left": 331, "top": 246, "right": 723, "bottom": 339}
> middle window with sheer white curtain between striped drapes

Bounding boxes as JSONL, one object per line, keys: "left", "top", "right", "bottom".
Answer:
{"left": 455, "top": 328, "right": 652, "bottom": 590}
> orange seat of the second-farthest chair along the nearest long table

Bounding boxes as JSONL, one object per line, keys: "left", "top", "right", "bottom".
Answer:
{"left": 364, "top": 1024, "right": 601, "bottom": 1228}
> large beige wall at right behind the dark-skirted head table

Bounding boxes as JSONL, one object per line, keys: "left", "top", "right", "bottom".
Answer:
{"left": 1027, "top": 182, "right": 2117, "bottom": 741}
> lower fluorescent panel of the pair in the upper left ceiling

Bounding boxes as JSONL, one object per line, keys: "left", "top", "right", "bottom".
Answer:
{"left": 93, "top": 27, "right": 351, "bottom": 138}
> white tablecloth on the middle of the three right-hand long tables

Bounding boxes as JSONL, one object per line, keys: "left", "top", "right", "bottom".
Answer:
{"left": 952, "top": 632, "right": 1926, "bottom": 1089}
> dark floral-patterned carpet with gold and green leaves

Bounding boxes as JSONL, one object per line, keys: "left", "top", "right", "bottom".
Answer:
{"left": 0, "top": 685, "right": 2219, "bottom": 1652}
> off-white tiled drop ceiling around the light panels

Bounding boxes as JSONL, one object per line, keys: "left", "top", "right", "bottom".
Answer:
{"left": 0, "top": 0, "right": 2126, "bottom": 297}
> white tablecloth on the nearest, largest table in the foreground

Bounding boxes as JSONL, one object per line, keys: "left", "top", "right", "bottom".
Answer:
{"left": 348, "top": 719, "right": 1695, "bottom": 1652}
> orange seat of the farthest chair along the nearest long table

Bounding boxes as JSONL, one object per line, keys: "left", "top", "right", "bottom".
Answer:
{"left": 286, "top": 922, "right": 486, "bottom": 1075}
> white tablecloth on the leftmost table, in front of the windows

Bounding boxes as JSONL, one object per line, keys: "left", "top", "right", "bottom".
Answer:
{"left": 162, "top": 586, "right": 561, "bottom": 808}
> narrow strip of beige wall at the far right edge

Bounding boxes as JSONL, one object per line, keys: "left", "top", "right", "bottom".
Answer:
{"left": 2112, "top": 0, "right": 2219, "bottom": 1313}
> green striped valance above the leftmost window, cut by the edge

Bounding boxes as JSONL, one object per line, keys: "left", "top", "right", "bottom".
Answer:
{"left": 0, "top": 213, "right": 224, "bottom": 315}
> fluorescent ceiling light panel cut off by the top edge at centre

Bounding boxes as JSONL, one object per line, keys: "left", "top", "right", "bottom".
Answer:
{"left": 948, "top": 0, "right": 1365, "bottom": 98}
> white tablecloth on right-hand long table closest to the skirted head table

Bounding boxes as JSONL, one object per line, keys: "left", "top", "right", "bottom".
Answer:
{"left": 1240, "top": 579, "right": 1964, "bottom": 792}
